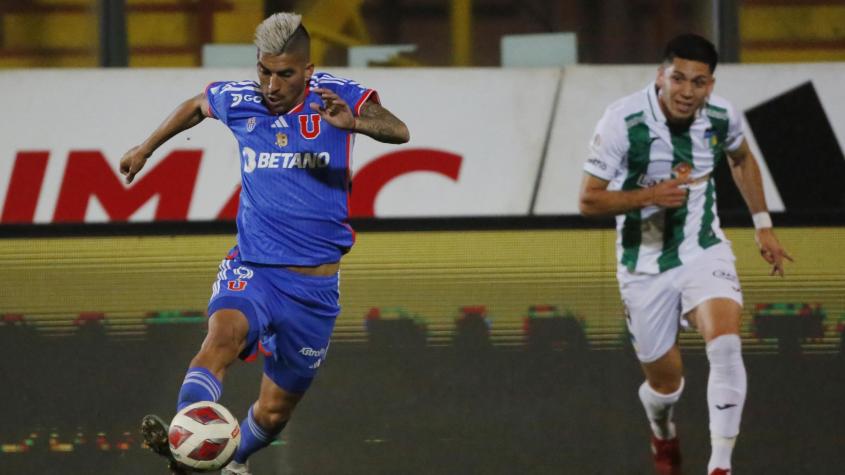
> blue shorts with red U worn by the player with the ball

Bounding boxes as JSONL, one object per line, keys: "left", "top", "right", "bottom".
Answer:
{"left": 208, "top": 246, "right": 340, "bottom": 393}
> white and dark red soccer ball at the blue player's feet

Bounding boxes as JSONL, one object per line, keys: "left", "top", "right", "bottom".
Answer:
{"left": 168, "top": 401, "right": 241, "bottom": 471}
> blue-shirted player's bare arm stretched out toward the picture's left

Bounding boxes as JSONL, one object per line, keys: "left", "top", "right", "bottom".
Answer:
{"left": 120, "top": 93, "right": 208, "bottom": 184}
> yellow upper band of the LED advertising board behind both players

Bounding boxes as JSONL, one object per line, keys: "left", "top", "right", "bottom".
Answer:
{"left": 0, "top": 228, "right": 845, "bottom": 349}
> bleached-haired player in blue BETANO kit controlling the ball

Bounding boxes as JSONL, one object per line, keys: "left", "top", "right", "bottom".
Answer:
{"left": 120, "top": 13, "right": 410, "bottom": 474}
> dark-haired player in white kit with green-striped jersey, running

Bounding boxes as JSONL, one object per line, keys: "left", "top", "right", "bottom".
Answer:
{"left": 579, "top": 34, "right": 792, "bottom": 475}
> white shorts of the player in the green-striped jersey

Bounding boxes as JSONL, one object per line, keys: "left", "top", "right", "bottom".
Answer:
{"left": 617, "top": 244, "right": 742, "bottom": 363}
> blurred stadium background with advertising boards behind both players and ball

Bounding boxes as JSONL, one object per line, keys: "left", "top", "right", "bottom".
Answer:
{"left": 0, "top": 0, "right": 845, "bottom": 474}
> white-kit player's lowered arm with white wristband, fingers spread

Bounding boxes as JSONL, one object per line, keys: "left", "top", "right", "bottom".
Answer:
{"left": 728, "top": 140, "right": 793, "bottom": 277}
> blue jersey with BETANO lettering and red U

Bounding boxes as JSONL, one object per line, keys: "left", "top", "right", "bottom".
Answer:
{"left": 206, "top": 73, "right": 378, "bottom": 266}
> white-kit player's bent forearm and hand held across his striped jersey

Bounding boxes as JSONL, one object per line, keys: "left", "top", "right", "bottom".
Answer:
{"left": 578, "top": 173, "right": 690, "bottom": 217}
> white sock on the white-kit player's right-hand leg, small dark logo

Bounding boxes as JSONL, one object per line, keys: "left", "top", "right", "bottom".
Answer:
{"left": 707, "top": 335, "right": 748, "bottom": 471}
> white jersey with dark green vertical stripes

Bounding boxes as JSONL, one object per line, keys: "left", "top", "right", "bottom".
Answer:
{"left": 584, "top": 83, "right": 744, "bottom": 274}
